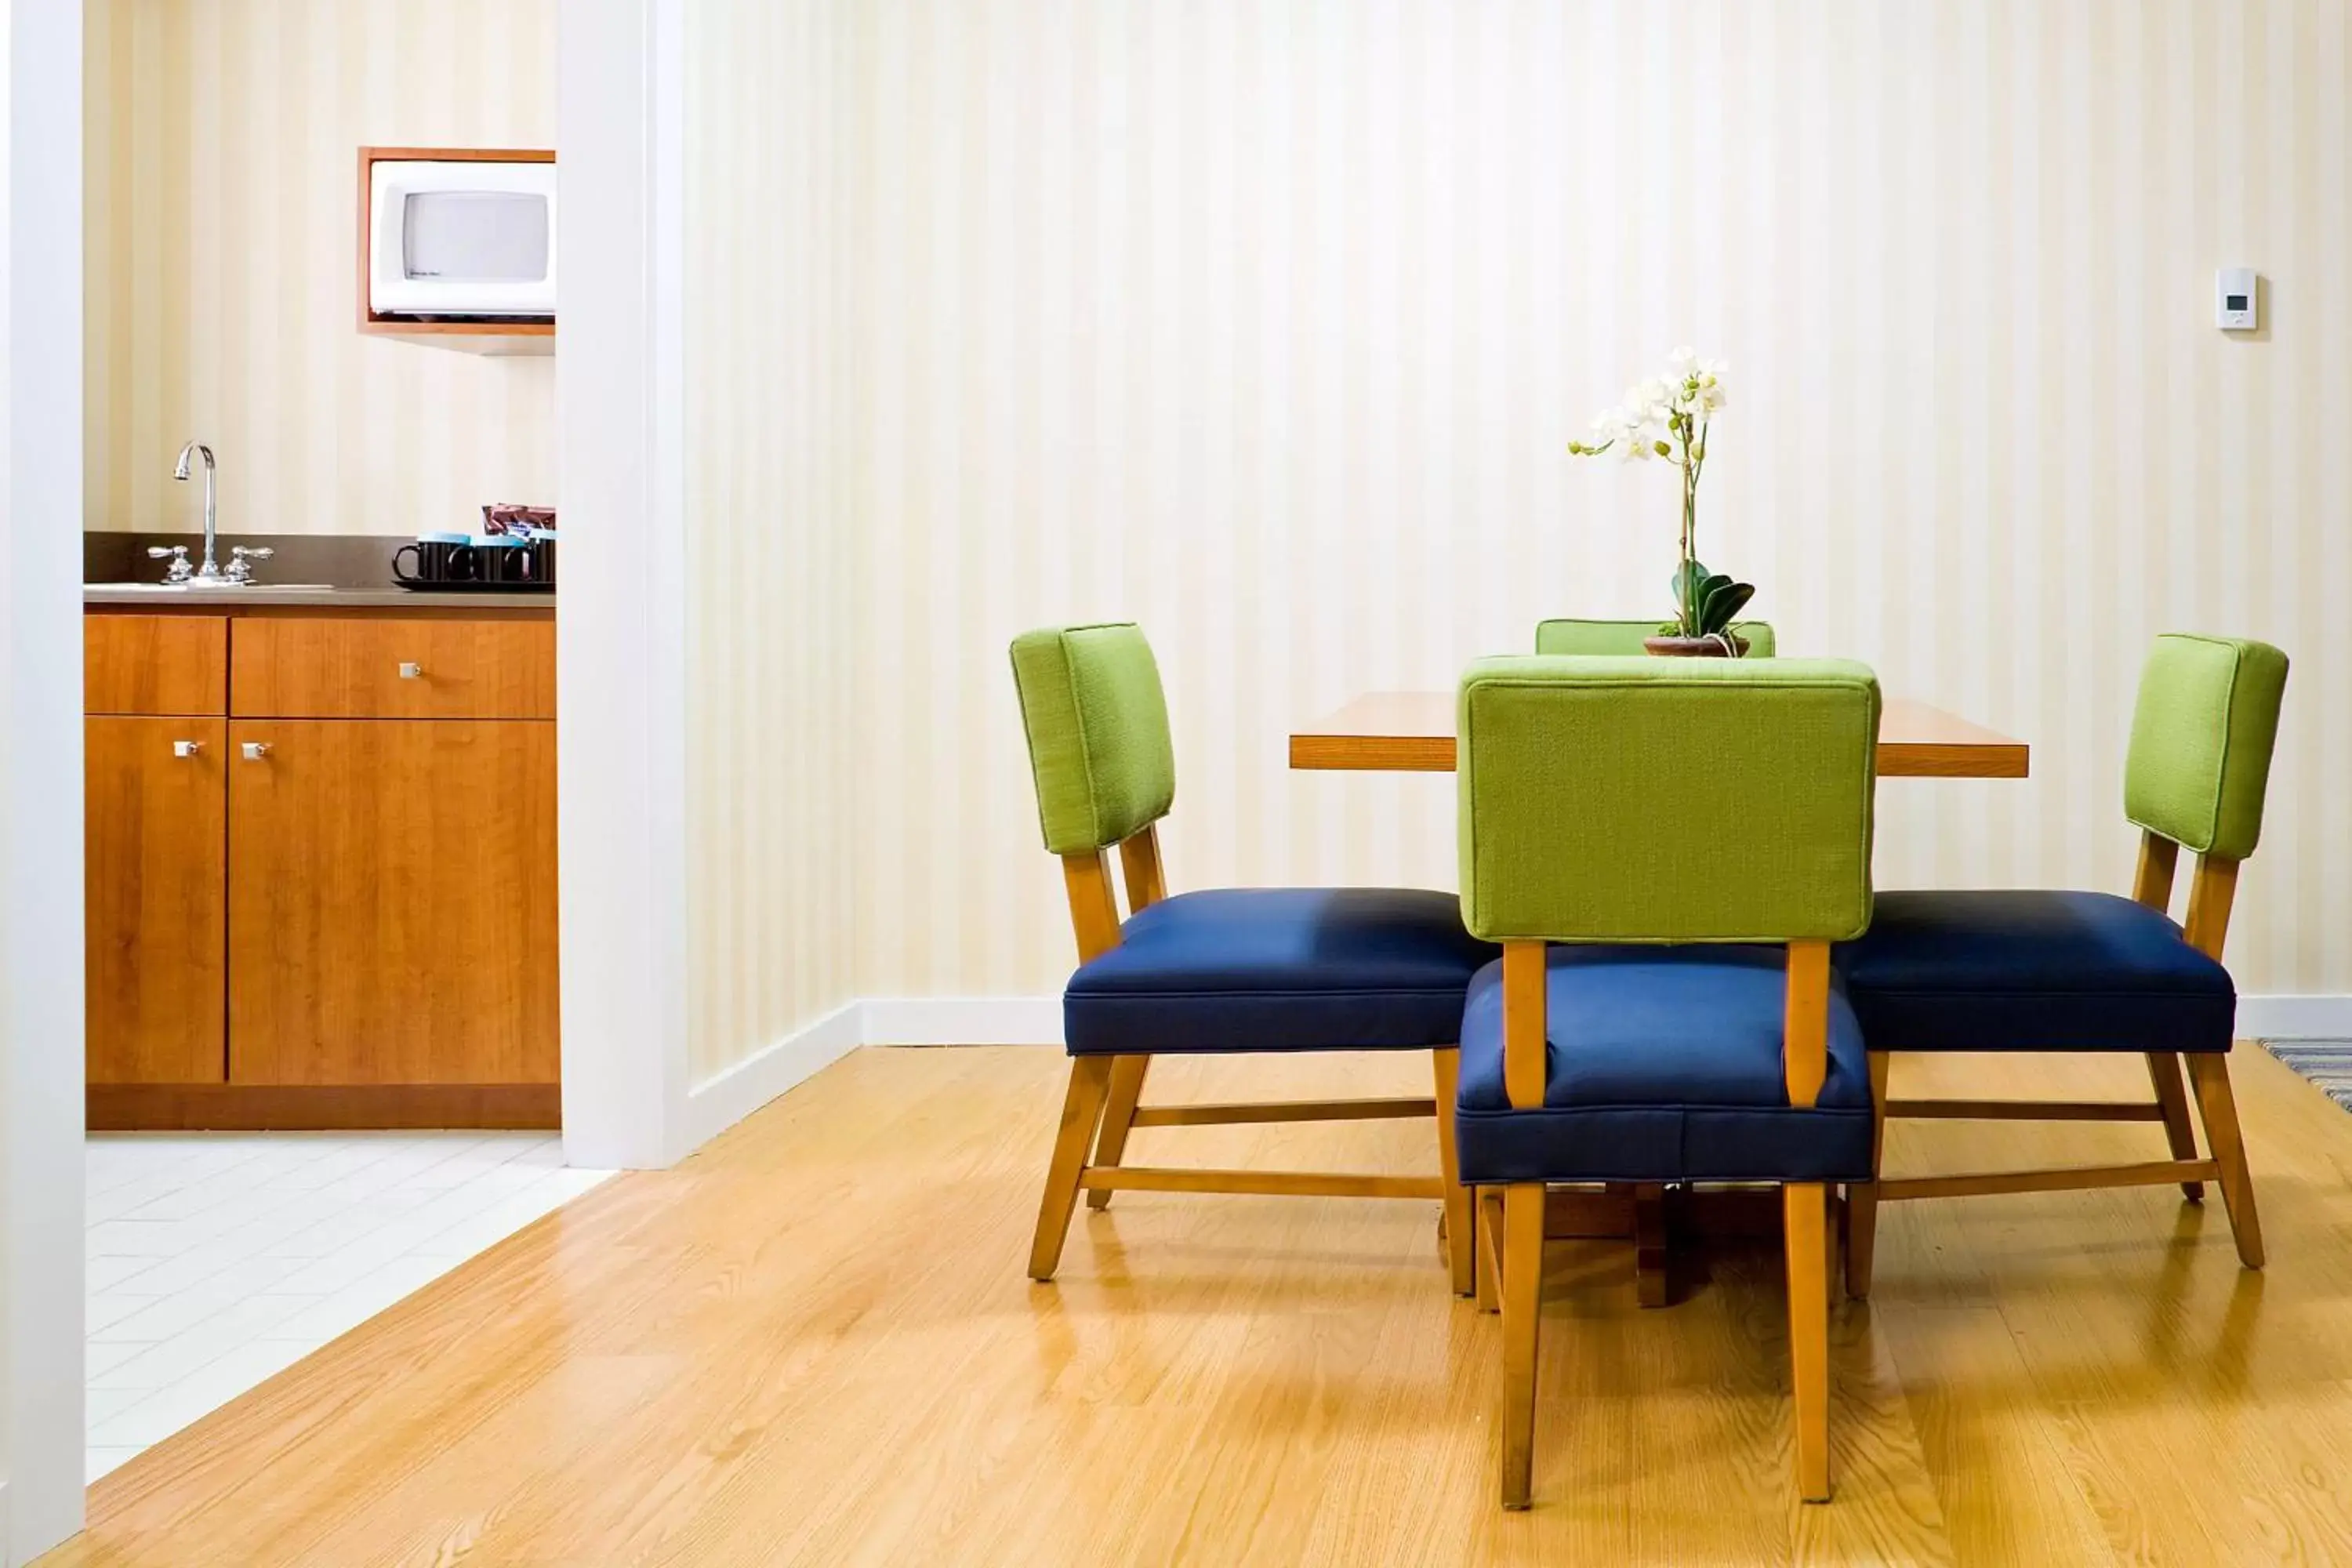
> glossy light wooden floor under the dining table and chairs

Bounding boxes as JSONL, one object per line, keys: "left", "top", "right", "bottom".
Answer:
{"left": 45, "top": 1046, "right": 2352, "bottom": 1568}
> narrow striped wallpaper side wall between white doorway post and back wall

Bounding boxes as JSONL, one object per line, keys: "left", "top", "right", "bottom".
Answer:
{"left": 684, "top": 0, "right": 868, "bottom": 1079}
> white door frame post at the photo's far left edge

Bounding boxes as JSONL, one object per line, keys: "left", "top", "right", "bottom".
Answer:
{"left": 0, "top": 0, "right": 82, "bottom": 1563}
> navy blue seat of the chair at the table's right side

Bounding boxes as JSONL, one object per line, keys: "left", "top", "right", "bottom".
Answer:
{"left": 1837, "top": 891, "right": 2237, "bottom": 1051}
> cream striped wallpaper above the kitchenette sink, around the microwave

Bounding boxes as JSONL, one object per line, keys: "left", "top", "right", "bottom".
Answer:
{"left": 85, "top": 0, "right": 557, "bottom": 534}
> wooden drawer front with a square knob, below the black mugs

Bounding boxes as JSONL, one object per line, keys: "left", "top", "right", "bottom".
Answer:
{"left": 228, "top": 616, "right": 555, "bottom": 720}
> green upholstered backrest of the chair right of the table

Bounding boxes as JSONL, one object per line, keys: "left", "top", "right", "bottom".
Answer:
{"left": 2124, "top": 633, "right": 2286, "bottom": 860}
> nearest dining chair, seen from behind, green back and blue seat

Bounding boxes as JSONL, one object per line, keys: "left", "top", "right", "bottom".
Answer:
{"left": 1454, "top": 656, "right": 1879, "bottom": 1509}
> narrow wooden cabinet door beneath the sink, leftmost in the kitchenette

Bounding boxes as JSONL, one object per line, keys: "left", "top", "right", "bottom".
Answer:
{"left": 82, "top": 717, "right": 228, "bottom": 1083}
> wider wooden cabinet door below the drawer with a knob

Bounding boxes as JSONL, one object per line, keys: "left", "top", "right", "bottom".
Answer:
{"left": 228, "top": 720, "right": 557, "bottom": 1083}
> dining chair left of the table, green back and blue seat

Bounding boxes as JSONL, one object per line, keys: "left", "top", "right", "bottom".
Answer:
{"left": 1011, "top": 623, "right": 1496, "bottom": 1295}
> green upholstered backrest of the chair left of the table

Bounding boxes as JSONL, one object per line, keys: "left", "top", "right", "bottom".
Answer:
{"left": 1014, "top": 621, "right": 1176, "bottom": 855}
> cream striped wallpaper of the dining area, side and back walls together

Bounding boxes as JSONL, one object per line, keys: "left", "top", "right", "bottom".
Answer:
{"left": 687, "top": 0, "right": 2352, "bottom": 1069}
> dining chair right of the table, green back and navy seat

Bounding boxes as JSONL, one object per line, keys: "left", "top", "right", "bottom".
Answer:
{"left": 1837, "top": 635, "right": 2286, "bottom": 1295}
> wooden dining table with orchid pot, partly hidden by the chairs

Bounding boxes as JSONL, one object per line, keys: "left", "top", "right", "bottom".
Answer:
{"left": 1291, "top": 691, "right": 2032, "bottom": 1307}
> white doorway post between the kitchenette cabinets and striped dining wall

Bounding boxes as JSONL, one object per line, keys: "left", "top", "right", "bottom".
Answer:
{"left": 555, "top": 0, "right": 687, "bottom": 1166}
